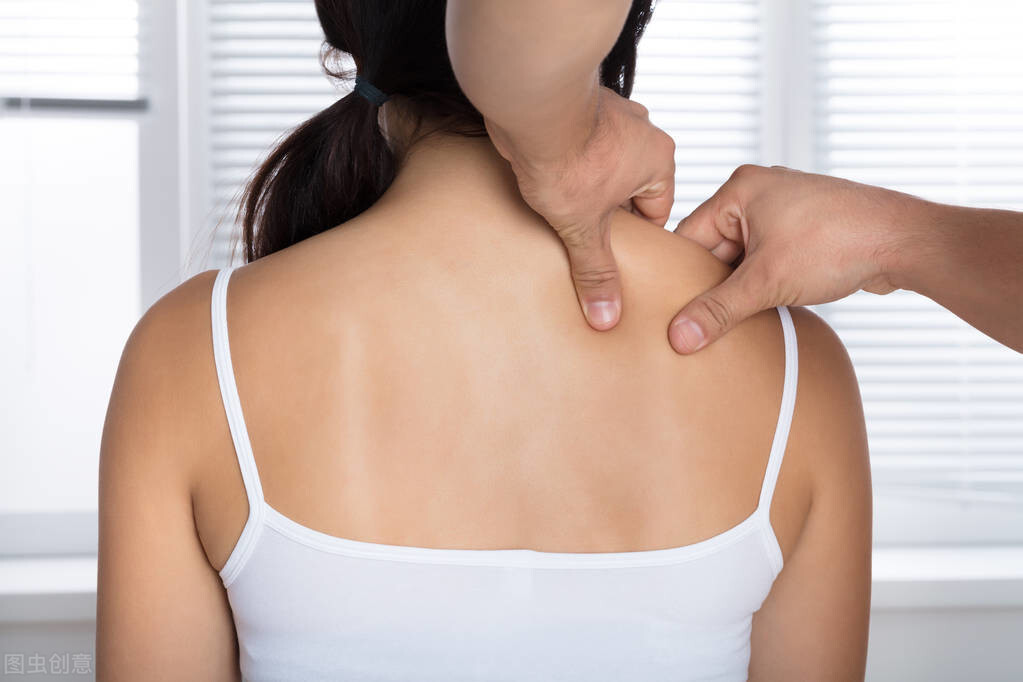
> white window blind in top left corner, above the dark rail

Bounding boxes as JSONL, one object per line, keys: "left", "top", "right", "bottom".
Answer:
{"left": 0, "top": 0, "right": 139, "bottom": 99}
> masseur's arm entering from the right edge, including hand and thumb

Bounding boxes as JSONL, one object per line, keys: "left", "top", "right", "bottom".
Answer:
{"left": 668, "top": 166, "right": 1023, "bottom": 353}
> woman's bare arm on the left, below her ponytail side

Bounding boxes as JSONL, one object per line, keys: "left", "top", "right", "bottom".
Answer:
{"left": 96, "top": 273, "right": 237, "bottom": 682}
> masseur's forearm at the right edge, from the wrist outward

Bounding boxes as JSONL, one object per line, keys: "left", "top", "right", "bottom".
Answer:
{"left": 891, "top": 199, "right": 1023, "bottom": 353}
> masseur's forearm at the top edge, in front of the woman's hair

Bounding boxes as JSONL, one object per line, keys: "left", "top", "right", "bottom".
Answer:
{"left": 446, "top": 0, "right": 631, "bottom": 161}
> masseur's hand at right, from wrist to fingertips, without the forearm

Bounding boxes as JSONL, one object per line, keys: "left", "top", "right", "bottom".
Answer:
{"left": 668, "top": 166, "right": 904, "bottom": 353}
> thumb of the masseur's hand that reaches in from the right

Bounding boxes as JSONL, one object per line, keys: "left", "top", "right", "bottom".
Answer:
{"left": 668, "top": 260, "right": 773, "bottom": 354}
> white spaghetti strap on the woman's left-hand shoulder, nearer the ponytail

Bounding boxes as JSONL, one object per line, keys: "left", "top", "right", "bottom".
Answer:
{"left": 211, "top": 267, "right": 264, "bottom": 583}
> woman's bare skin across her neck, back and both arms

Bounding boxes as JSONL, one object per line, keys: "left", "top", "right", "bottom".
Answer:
{"left": 97, "top": 136, "right": 871, "bottom": 681}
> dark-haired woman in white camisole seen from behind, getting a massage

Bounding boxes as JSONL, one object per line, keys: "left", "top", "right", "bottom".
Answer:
{"left": 97, "top": 2, "right": 871, "bottom": 680}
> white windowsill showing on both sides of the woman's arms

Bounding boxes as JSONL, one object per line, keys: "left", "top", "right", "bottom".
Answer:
{"left": 0, "top": 546, "right": 1023, "bottom": 623}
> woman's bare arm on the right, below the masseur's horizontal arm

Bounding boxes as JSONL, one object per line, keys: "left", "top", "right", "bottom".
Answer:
{"left": 750, "top": 309, "right": 872, "bottom": 681}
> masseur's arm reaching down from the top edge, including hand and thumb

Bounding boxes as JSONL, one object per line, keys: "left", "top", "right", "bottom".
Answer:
{"left": 446, "top": 0, "right": 675, "bottom": 329}
